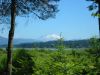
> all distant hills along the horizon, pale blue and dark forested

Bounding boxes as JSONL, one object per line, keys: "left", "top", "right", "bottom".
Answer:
{"left": 0, "top": 38, "right": 90, "bottom": 48}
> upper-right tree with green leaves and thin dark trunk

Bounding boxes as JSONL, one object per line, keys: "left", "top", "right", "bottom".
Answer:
{"left": 87, "top": 0, "right": 100, "bottom": 39}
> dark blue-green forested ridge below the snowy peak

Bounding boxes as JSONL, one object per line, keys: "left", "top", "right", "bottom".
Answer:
{"left": 0, "top": 40, "right": 90, "bottom": 48}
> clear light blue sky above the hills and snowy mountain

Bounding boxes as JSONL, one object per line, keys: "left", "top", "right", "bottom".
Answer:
{"left": 0, "top": 0, "right": 99, "bottom": 40}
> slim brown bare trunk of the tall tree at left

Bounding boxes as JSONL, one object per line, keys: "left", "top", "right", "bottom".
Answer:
{"left": 7, "top": 0, "right": 16, "bottom": 75}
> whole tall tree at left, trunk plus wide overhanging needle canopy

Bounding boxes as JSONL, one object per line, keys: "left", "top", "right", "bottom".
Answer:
{"left": 0, "top": 0, "right": 59, "bottom": 75}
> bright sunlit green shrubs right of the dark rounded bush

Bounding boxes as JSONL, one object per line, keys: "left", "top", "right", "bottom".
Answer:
{"left": 30, "top": 50, "right": 96, "bottom": 75}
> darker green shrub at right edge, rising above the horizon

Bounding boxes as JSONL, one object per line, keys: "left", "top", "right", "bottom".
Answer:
{"left": 86, "top": 38, "right": 100, "bottom": 75}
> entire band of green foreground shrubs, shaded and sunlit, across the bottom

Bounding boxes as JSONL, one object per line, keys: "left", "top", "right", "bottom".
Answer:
{"left": 0, "top": 48, "right": 100, "bottom": 75}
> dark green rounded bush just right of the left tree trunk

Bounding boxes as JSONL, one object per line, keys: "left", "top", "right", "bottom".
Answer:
{"left": 13, "top": 49, "right": 34, "bottom": 75}
